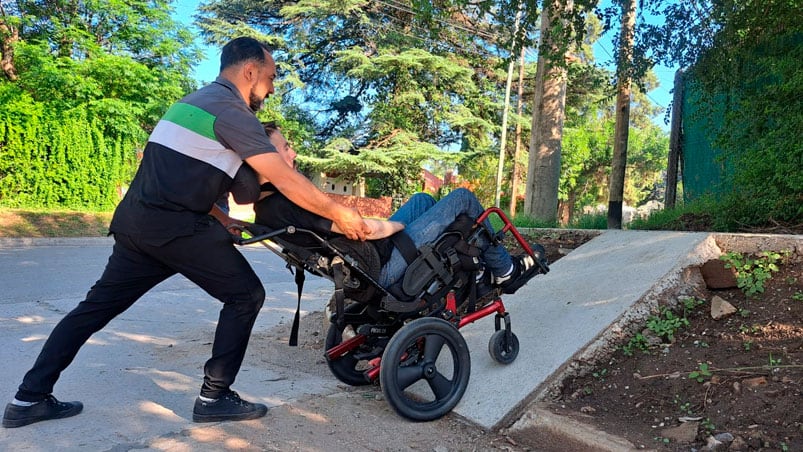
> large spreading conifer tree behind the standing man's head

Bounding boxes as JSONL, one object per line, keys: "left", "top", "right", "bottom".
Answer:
{"left": 199, "top": 1, "right": 532, "bottom": 200}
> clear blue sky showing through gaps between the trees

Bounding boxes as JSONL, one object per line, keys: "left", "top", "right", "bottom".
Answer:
{"left": 173, "top": 0, "right": 677, "bottom": 131}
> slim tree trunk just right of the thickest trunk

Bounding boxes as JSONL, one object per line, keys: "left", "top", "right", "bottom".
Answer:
{"left": 608, "top": 0, "right": 636, "bottom": 229}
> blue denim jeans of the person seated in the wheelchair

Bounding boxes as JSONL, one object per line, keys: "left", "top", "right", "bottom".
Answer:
{"left": 379, "top": 188, "right": 513, "bottom": 287}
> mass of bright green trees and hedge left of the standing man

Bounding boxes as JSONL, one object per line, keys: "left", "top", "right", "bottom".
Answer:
{"left": 0, "top": 0, "right": 199, "bottom": 209}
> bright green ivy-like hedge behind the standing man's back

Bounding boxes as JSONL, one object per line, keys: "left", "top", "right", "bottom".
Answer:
{"left": 0, "top": 85, "right": 145, "bottom": 210}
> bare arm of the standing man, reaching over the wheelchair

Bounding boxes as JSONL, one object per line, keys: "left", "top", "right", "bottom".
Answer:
{"left": 245, "top": 152, "right": 372, "bottom": 240}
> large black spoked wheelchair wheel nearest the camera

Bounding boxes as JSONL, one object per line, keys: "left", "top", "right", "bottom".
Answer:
{"left": 379, "top": 317, "right": 471, "bottom": 421}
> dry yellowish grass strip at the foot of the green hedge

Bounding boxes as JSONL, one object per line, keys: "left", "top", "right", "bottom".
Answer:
{"left": 0, "top": 208, "right": 112, "bottom": 238}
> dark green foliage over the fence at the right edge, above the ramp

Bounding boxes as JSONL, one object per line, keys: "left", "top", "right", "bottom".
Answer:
{"left": 642, "top": 0, "right": 803, "bottom": 230}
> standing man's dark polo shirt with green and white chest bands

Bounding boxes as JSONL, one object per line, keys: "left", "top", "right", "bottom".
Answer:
{"left": 109, "top": 78, "right": 276, "bottom": 241}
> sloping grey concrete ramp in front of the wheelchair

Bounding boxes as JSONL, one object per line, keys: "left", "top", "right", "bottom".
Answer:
{"left": 454, "top": 230, "right": 720, "bottom": 429}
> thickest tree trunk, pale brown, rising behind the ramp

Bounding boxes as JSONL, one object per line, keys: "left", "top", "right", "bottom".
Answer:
{"left": 524, "top": 0, "right": 572, "bottom": 223}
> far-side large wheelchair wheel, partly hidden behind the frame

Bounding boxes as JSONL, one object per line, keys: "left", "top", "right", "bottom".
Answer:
{"left": 324, "top": 304, "right": 379, "bottom": 386}
